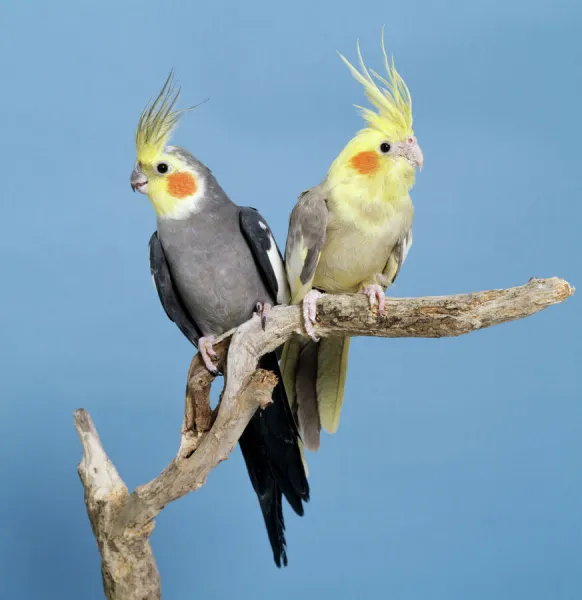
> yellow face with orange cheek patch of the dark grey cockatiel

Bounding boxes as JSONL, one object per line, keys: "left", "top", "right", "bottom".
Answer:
{"left": 131, "top": 152, "right": 201, "bottom": 216}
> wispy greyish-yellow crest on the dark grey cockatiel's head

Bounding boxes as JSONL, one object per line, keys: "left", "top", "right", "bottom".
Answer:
{"left": 135, "top": 71, "right": 190, "bottom": 163}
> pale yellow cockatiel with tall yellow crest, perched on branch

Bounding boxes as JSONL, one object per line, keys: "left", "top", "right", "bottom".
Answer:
{"left": 281, "top": 36, "right": 423, "bottom": 450}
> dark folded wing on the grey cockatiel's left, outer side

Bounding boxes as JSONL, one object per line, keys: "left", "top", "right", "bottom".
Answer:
{"left": 149, "top": 231, "right": 201, "bottom": 347}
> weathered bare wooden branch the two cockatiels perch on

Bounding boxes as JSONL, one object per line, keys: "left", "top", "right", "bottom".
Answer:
{"left": 75, "top": 278, "right": 574, "bottom": 600}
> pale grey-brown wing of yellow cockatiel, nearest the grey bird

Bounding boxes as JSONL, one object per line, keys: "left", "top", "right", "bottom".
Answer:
{"left": 285, "top": 185, "right": 329, "bottom": 304}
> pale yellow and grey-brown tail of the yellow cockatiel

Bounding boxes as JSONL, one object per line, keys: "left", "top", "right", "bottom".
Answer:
{"left": 281, "top": 336, "right": 350, "bottom": 450}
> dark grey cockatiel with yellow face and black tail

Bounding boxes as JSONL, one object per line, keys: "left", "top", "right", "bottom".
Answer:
{"left": 131, "top": 74, "right": 309, "bottom": 566}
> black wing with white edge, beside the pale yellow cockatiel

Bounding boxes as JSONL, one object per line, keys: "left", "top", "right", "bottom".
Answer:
{"left": 240, "top": 207, "right": 289, "bottom": 304}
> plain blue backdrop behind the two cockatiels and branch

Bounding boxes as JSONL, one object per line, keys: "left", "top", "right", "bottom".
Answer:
{"left": 0, "top": 0, "right": 582, "bottom": 600}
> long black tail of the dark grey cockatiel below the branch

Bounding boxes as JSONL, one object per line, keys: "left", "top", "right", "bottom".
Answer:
{"left": 239, "top": 353, "right": 309, "bottom": 567}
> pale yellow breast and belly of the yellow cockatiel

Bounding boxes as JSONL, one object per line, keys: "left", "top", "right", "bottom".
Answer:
{"left": 313, "top": 195, "right": 414, "bottom": 293}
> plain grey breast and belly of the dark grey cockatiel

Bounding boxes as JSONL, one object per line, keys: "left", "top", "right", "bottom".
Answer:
{"left": 158, "top": 204, "right": 274, "bottom": 336}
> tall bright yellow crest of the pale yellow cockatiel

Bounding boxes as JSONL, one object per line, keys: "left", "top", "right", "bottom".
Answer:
{"left": 338, "top": 29, "right": 414, "bottom": 141}
